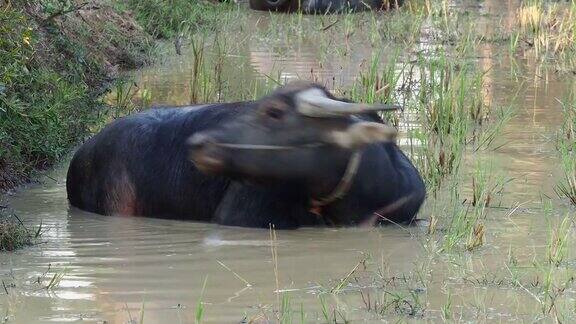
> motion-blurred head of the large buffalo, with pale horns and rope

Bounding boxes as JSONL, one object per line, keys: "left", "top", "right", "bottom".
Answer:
{"left": 188, "top": 82, "right": 398, "bottom": 186}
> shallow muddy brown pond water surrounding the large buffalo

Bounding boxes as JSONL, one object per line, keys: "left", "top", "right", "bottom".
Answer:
{"left": 0, "top": 0, "right": 576, "bottom": 323}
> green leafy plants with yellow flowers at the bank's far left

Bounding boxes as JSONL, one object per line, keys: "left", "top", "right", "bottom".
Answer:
{"left": 0, "top": 3, "right": 87, "bottom": 186}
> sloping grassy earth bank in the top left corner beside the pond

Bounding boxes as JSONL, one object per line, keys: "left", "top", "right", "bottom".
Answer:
{"left": 0, "top": 1, "right": 154, "bottom": 189}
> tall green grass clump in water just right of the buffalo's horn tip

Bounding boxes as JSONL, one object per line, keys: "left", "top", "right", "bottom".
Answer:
{"left": 412, "top": 53, "right": 482, "bottom": 192}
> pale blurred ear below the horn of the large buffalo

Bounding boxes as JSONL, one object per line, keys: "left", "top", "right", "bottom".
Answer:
{"left": 328, "top": 122, "right": 398, "bottom": 149}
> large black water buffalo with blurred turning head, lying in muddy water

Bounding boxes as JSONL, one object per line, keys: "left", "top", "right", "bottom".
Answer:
{"left": 66, "top": 82, "right": 425, "bottom": 228}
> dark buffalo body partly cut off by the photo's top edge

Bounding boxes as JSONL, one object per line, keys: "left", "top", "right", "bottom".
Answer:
{"left": 250, "top": 0, "right": 404, "bottom": 14}
